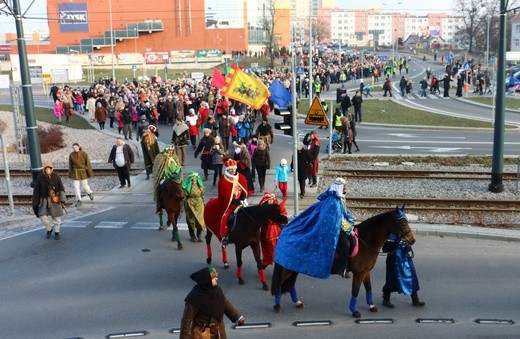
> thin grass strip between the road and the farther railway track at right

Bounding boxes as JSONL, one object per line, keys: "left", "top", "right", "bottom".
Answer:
{"left": 330, "top": 155, "right": 518, "bottom": 167}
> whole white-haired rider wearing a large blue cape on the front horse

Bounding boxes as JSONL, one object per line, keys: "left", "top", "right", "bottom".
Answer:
{"left": 274, "top": 178, "right": 354, "bottom": 279}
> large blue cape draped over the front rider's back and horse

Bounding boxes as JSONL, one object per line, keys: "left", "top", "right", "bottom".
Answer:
{"left": 274, "top": 190, "right": 347, "bottom": 279}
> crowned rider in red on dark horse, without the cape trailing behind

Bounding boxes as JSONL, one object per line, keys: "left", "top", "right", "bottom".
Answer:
{"left": 215, "top": 159, "right": 247, "bottom": 246}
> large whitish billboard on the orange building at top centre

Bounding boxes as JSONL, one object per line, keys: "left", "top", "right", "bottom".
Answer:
{"left": 204, "top": 0, "right": 245, "bottom": 29}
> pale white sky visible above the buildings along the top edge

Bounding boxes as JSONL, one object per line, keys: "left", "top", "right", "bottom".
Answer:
{"left": 0, "top": 0, "right": 456, "bottom": 33}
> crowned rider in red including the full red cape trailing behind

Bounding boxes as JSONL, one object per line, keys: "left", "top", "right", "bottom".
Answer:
{"left": 204, "top": 159, "right": 247, "bottom": 245}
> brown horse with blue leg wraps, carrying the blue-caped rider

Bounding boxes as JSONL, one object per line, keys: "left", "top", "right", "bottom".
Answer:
{"left": 271, "top": 205, "right": 415, "bottom": 318}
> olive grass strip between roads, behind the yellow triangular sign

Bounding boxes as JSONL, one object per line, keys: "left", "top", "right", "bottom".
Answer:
{"left": 298, "top": 99, "right": 496, "bottom": 128}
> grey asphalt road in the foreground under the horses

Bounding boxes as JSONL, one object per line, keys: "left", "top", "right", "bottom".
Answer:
{"left": 0, "top": 211, "right": 520, "bottom": 338}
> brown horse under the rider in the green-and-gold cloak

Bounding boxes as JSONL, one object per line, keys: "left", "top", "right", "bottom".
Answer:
{"left": 157, "top": 180, "right": 184, "bottom": 250}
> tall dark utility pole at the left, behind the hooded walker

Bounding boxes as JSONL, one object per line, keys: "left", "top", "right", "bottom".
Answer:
{"left": 13, "top": 0, "right": 43, "bottom": 186}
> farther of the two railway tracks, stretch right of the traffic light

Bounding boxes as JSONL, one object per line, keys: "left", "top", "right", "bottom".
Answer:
{"left": 323, "top": 169, "right": 520, "bottom": 180}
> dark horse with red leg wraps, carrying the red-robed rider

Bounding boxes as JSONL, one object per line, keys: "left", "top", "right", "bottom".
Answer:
{"left": 206, "top": 204, "right": 288, "bottom": 291}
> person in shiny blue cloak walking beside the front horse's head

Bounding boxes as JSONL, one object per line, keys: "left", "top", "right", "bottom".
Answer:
{"left": 383, "top": 233, "right": 425, "bottom": 308}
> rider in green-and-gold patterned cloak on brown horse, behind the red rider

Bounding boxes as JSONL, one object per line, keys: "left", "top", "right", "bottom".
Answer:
{"left": 153, "top": 145, "right": 182, "bottom": 213}
